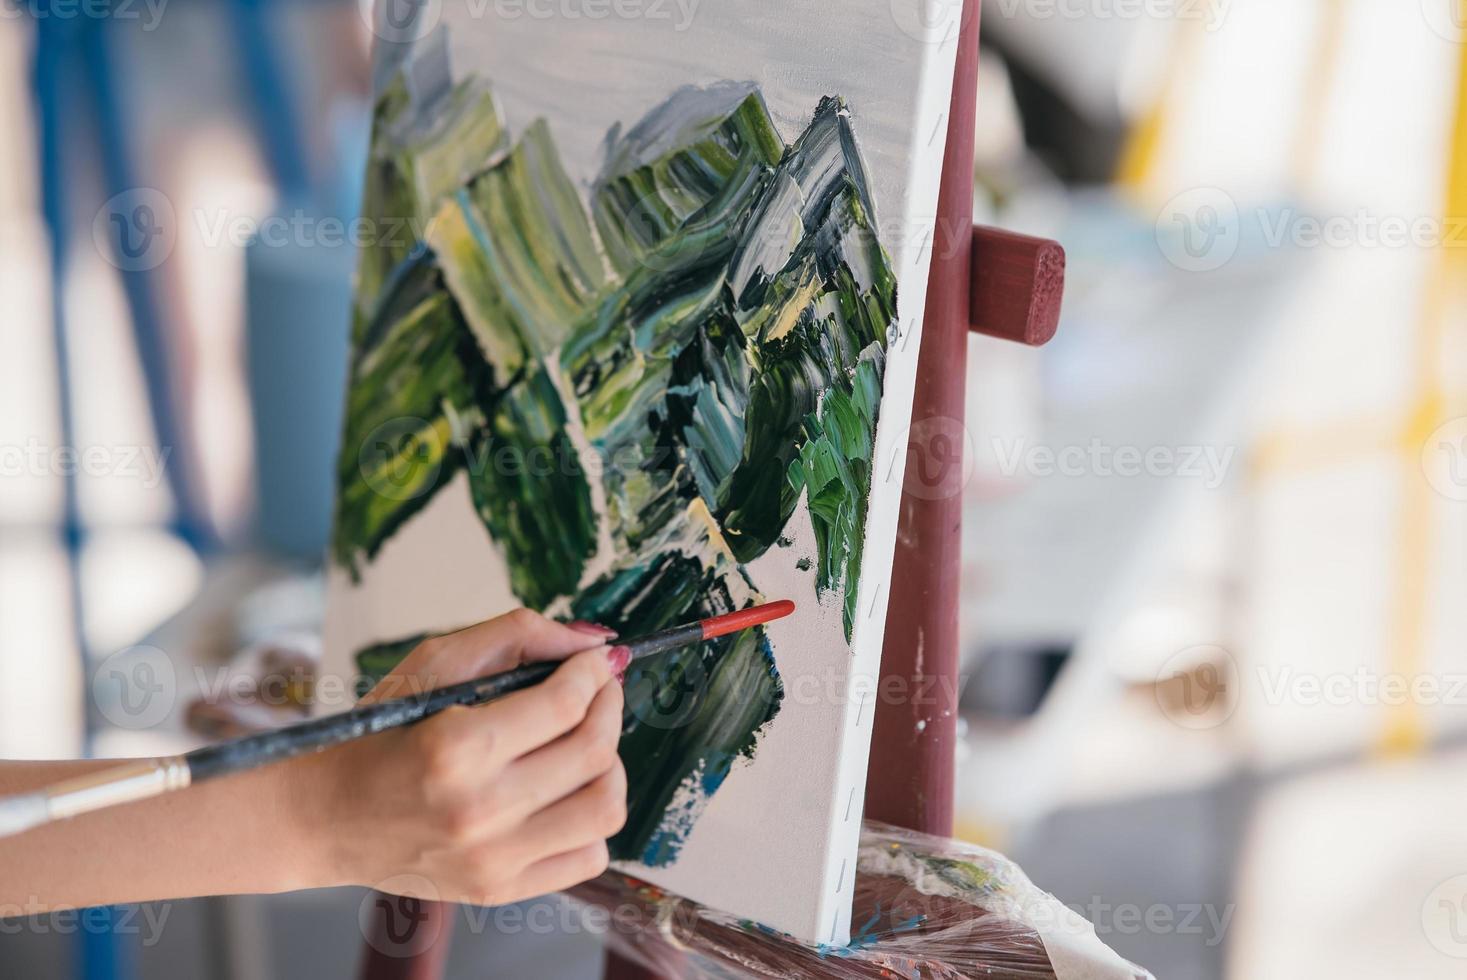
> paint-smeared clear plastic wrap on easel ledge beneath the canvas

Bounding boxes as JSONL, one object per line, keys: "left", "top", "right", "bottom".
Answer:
{"left": 572, "top": 822, "right": 1150, "bottom": 980}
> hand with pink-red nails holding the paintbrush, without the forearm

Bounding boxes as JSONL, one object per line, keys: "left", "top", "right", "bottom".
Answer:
{"left": 295, "top": 609, "right": 626, "bottom": 905}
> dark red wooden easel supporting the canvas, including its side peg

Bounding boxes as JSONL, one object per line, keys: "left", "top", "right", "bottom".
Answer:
{"left": 362, "top": 0, "right": 1065, "bottom": 980}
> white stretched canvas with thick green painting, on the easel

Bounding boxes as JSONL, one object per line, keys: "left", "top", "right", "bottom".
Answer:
{"left": 326, "top": 0, "right": 956, "bottom": 943}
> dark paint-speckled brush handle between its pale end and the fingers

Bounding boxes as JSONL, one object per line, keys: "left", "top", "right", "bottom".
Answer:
{"left": 183, "top": 662, "right": 560, "bottom": 782}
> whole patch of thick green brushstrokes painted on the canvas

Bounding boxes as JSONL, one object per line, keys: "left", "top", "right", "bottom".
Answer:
{"left": 337, "top": 59, "right": 896, "bottom": 864}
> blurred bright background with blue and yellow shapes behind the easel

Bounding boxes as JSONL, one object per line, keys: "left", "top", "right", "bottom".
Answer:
{"left": 0, "top": 0, "right": 1467, "bottom": 980}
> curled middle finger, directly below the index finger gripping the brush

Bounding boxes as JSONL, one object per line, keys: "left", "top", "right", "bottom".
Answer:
{"left": 496, "top": 684, "right": 622, "bottom": 822}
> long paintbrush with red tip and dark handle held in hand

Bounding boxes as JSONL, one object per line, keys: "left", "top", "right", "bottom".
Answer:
{"left": 0, "top": 599, "right": 795, "bottom": 838}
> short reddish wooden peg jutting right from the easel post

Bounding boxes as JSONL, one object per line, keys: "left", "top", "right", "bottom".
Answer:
{"left": 968, "top": 224, "right": 1065, "bottom": 348}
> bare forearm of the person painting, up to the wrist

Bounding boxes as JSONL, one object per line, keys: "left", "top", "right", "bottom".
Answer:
{"left": 0, "top": 757, "right": 337, "bottom": 914}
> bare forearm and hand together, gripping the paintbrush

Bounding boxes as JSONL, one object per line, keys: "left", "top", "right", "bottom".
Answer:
{"left": 0, "top": 610, "right": 626, "bottom": 917}
